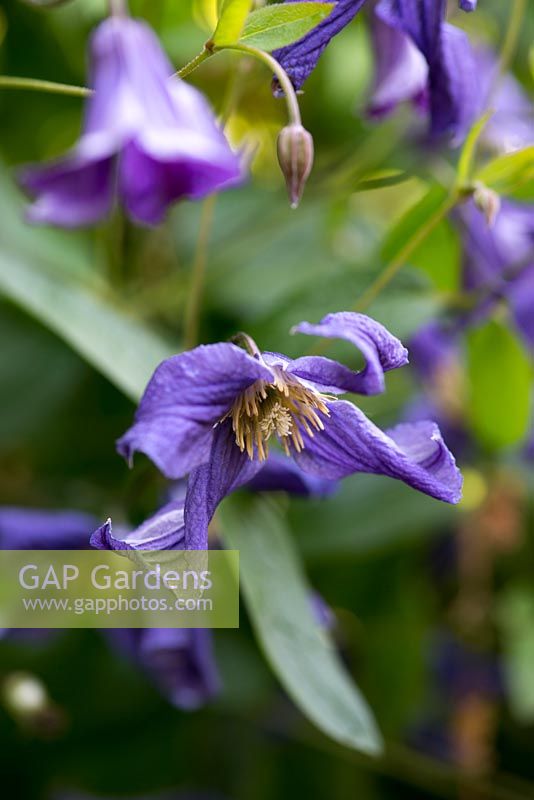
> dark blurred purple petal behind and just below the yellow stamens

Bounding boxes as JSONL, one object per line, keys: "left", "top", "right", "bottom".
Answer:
{"left": 246, "top": 453, "right": 337, "bottom": 497}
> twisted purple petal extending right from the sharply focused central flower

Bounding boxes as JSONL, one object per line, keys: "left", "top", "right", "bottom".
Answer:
{"left": 296, "top": 400, "right": 462, "bottom": 503}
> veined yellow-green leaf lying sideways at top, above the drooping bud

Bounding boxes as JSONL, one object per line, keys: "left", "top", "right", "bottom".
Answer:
{"left": 240, "top": 2, "right": 334, "bottom": 51}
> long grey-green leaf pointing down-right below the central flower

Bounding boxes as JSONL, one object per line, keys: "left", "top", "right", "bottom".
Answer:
{"left": 220, "top": 497, "right": 381, "bottom": 755}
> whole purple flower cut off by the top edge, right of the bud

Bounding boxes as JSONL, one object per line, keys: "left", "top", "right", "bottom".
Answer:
{"left": 274, "top": 0, "right": 478, "bottom": 143}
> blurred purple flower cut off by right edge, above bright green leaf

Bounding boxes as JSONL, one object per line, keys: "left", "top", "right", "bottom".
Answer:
{"left": 456, "top": 201, "right": 534, "bottom": 349}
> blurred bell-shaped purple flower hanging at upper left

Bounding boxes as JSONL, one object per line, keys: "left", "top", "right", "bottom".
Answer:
{"left": 21, "top": 17, "right": 241, "bottom": 227}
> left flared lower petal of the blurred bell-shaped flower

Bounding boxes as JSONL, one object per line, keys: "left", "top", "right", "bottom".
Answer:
{"left": 19, "top": 151, "right": 114, "bottom": 228}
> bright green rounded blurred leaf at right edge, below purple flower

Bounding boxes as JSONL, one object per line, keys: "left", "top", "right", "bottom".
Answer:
{"left": 467, "top": 322, "right": 532, "bottom": 450}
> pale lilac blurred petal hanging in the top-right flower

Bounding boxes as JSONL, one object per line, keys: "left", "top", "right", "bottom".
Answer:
{"left": 368, "top": 14, "right": 428, "bottom": 117}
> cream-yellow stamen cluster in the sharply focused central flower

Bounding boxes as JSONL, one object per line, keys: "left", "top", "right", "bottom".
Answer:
{"left": 224, "top": 367, "right": 330, "bottom": 461}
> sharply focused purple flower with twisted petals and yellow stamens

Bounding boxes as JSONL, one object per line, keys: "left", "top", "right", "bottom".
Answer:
{"left": 118, "top": 313, "right": 462, "bottom": 549}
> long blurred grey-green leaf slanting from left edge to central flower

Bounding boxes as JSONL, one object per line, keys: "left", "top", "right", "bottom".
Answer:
{"left": 0, "top": 172, "right": 178, "bottom": 401}
